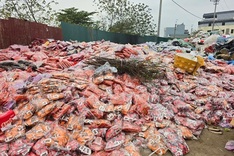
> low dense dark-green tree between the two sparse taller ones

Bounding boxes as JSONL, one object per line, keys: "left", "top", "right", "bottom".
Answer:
{"left": 57, "top": 7, "right": 96, "bottom": 26}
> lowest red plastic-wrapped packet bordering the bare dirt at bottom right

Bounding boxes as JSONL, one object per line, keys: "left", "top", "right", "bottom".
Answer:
{"left": 159, "top": 127, "right": 189, "bottom": 156}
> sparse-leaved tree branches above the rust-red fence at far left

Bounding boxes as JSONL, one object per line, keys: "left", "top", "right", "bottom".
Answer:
{"left": 0, "top": 0, "right": 57, "bottom": 25}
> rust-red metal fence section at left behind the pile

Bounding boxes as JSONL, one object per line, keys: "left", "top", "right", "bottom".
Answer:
{"left": 0, "top": 18, "right": 63, "bottom": 49}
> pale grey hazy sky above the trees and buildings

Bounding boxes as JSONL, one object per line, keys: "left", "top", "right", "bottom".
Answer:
{"left": 52, "top": 0, "right": 234, "bottom": 36}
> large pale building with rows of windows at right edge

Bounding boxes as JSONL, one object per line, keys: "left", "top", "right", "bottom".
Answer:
{"left": 198, "top": 10, "right": 234, "bottom": 35}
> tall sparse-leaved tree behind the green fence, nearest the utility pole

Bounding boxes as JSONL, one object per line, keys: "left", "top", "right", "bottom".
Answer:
{"left": 94, "top": 0, "right": 156, "bottom": 35}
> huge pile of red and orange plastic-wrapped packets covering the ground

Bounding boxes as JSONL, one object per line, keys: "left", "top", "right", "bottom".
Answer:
{"left": 0, "top": 36, "right": 234, "bottom": 156}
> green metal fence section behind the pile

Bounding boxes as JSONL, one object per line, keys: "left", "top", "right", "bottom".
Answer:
{"left": 61, "top": 22, "right": 171, "bottom": 44}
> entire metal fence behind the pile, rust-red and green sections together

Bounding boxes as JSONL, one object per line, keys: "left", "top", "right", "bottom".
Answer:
{"left": 0, "top": 18, "right": 170, "bottom": 49}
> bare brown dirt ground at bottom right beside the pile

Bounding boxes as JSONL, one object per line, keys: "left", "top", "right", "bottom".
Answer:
{"left": 141, "top": 129, "right": 234, "bottom": 156}
